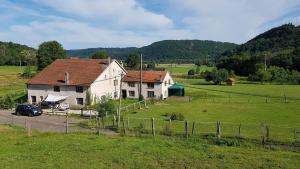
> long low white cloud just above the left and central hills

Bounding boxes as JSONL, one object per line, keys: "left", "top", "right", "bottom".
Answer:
{"left": 0, "top": 17, "right": 193, "bottom": 49}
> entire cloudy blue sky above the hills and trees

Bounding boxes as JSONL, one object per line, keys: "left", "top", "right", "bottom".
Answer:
{"left": 0, "top": 0, "right": 300, "bottom": 49}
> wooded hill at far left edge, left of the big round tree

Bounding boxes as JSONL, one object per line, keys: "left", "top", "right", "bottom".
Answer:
{"left": 0, "top": 42, "right": 35, "bottom": 65}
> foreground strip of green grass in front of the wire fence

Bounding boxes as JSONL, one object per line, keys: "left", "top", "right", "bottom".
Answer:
{"left": 0, "top": 125, "right": 300, "bottom": 169}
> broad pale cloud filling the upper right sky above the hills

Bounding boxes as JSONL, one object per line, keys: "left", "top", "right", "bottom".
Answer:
{"left": 170, "top": 0, "right": 300, "bottom": 43}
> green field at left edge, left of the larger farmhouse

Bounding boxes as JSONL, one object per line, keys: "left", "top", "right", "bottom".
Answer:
{"left": 0, "top": 66, "right": 28, "bottom": 96}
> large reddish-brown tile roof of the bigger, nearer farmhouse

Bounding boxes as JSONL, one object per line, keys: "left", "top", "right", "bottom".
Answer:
{"left": 27, "top": 59, "right": 108, "bottom": 86}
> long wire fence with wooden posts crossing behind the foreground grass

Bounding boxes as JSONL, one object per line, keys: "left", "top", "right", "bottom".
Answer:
{"left": 0, "top": 111, "right": 300, "bottom": 147}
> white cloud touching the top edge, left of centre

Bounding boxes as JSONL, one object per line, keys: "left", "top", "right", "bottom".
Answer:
{"left": 35, "top": 0, "right": 172, "bottom": 28}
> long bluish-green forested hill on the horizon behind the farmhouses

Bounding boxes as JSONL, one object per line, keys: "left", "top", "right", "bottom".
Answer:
{"left": 67, "top": 40, "right": 237, "bottom": 63}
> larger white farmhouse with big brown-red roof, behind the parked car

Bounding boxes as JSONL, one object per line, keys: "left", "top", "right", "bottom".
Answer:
{"left": 27, "top": 59, "right": 126, "bottom": 106}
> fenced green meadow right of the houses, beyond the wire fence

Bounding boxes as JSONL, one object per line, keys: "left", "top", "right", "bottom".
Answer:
{"left": 120, "top": 65, "right": 300, "bottom": 142}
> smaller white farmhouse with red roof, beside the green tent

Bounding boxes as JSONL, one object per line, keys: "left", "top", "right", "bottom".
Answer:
{"left": 122, "top": 71, "right": 174, "bottom": 99}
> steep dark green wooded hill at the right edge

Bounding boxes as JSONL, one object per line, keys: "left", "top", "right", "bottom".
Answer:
{"left": 218, "top": 24, "right": 300, "bottom": 75}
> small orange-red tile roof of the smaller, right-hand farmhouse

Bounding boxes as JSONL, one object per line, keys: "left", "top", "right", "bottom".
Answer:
{"left": 123, "top": 71, "right": 167, "bottom": 83}
